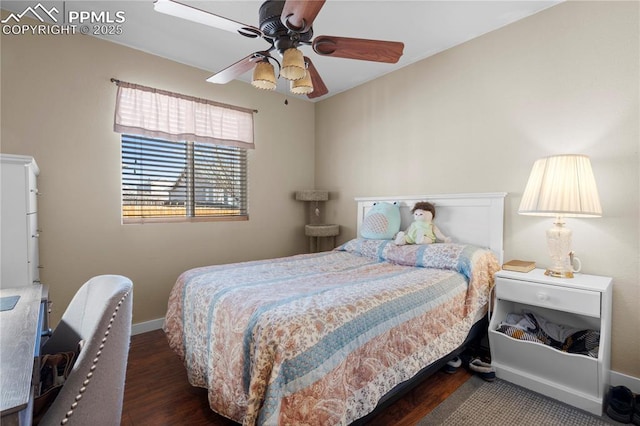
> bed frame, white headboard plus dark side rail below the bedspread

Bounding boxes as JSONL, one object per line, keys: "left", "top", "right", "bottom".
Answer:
{"left": 352, "top": 192, "right": 507, "bottom": 426}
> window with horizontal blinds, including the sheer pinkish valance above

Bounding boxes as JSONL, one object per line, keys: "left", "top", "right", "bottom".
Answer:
{"left": 111, "top": 79, "right": 257, "bottom": 223}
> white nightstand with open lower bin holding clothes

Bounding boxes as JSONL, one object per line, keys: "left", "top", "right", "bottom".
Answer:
{"left": 489, "top": 269, "right": 612, "bottom": 416}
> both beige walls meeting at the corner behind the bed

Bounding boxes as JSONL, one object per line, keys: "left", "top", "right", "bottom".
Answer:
{"left": 0, "top": 2, "right": 640, "bottom": 377}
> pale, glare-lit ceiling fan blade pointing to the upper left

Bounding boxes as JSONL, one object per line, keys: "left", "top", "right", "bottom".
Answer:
{"left": 153, "top": 0, "right": 262, "bottom": 38}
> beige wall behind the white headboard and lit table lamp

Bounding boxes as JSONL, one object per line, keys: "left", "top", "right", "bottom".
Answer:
{"left": 315, "top": 2, "right": 640, "bottom": 377}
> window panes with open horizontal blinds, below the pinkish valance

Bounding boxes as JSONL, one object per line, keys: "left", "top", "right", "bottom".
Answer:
{"left": 121, "top": 134, "right": 248, "bottom": 223}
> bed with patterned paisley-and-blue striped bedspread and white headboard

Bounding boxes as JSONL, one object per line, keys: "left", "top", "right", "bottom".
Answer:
{"left": 164, "top": 193, "right": 505, "bottom": 425}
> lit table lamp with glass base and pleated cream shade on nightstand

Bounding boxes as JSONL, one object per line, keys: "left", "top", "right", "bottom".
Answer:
{"left": 518, "top": 155, "right": 602, "bottom": 278}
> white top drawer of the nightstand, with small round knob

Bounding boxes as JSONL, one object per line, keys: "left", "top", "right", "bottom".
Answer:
{"left": 496, "top": 278, "right": 600, "bottom": 318}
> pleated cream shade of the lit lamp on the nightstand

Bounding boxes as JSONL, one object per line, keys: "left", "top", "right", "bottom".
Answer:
{"left": 518, "top": 155, "right": 602, "bottom": 217}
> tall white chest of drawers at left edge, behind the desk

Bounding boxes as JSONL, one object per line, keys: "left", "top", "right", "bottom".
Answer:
{"left": 0, "top": 154, "right": 40, "bottom": 288}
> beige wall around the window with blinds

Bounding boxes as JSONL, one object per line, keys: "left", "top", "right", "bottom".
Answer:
{"left": 0, "top": 15, "right": 314, "bottom": 324}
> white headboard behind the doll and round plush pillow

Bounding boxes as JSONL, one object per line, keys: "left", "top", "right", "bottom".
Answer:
{"left": 355, "top": 192, "right": 507, "bottom": 264}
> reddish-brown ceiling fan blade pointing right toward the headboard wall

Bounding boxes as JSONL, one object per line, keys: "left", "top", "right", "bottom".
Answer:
{"left": 312, "top": 36, "right": 404, "bottom": 64}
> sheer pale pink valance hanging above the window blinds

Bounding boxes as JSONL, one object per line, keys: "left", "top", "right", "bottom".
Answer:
{"left": 113, "top": 81, "right": 255, "bottom": 149}
